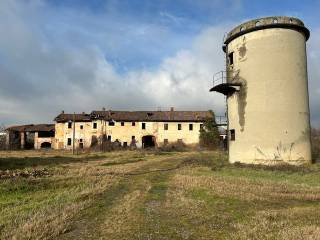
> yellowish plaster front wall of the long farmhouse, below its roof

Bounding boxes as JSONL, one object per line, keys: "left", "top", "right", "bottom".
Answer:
{"left": 53, "top": 120, "right": 201, "bottom": 149}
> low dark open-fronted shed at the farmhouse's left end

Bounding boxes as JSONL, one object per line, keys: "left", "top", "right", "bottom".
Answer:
{"left": 6, "top": 124, "right": 55, "bottom": 150}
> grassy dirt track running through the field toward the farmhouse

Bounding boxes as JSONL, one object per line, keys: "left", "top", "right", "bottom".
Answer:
{"left": 58, "top": 153, "right": 183, "bottom": 239}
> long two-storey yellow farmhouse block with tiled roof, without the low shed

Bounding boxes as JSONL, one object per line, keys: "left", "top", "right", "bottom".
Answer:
{"left": 53, "top": 108, "right": 211, "bottom": 149}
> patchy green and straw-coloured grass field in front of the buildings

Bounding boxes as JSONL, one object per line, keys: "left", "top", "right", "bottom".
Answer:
{"left": 0, "top": 151, "right": 320, "bottom": 240}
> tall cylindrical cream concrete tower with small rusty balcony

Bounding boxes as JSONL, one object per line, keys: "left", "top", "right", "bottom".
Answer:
{"left": 211, "top": 17, "right": 311, "bottom": 164}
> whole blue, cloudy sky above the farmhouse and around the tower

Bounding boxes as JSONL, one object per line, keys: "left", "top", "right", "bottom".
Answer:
{"left": 0, "top": 0, "right": 320, "bottom": 127}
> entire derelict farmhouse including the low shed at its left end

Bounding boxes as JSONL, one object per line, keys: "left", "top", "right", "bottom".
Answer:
{"left": 7, "top": 108, "right": 212, "bottom": 149}
